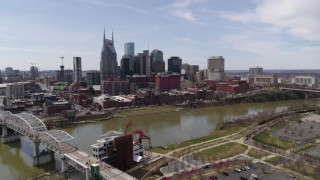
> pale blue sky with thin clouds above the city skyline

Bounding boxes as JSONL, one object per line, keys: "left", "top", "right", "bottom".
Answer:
{"left": 0, "top": 0, "right": 320, "bottom": 70}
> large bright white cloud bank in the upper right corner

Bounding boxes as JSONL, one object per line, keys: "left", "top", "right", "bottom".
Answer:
{"left": 221, "top": 0, "right": 320, "bottom": 41}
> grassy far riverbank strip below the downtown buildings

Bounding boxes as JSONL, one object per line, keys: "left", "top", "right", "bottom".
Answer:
{"left": 44, "top": 89, "right": 314, "bottom": 129}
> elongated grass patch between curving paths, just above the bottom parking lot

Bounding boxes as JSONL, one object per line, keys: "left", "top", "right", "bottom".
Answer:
{"left": 195, "top": 142, "right": 248, "bottom": 160}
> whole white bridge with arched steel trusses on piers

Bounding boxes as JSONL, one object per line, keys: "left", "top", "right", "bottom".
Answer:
{"left": 0, "top": 111, "right": 136, "bottom": 180}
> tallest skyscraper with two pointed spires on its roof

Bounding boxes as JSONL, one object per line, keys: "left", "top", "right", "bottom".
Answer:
{"left": 100, "top": 29, "right": 119, "bottom": 80}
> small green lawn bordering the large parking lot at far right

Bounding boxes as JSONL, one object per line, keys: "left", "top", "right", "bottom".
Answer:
{"left": 254, "top": 132, "right": 295, "bottom": 150}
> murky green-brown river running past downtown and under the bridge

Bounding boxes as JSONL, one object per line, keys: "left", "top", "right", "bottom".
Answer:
{"left": 0, "top": 99, "right": 320, "bottom": 180}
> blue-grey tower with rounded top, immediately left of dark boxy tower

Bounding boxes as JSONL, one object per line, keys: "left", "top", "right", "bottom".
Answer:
{"left": 150, "top": 49, "right": 166, "bottom": 73}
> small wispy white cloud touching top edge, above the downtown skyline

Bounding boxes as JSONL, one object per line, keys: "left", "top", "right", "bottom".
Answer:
{"left": 162, "top": 0, "right": 207, "bottom": 22}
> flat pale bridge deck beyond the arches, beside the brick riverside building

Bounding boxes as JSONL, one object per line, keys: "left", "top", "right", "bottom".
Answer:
{"left": 67, "top": 151, "right": 136, "bottom": 180}
